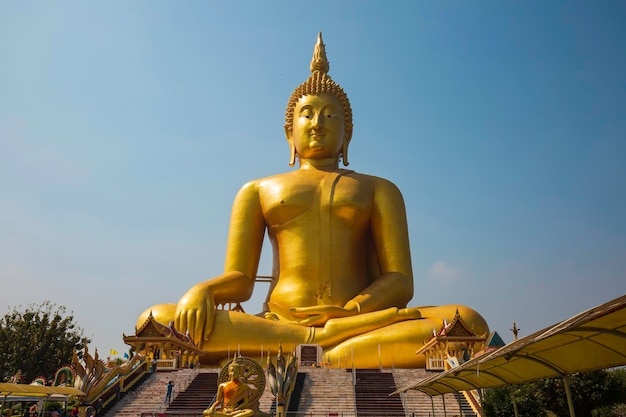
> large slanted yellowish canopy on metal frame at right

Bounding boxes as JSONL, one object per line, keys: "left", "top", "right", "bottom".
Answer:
{"left": 392, "top": 295, "right": 626, "bottom": 417}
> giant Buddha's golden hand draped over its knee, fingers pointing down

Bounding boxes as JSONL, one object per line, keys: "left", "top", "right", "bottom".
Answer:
{"left": 174, "top": 281, "right": 215, "bottom": 343}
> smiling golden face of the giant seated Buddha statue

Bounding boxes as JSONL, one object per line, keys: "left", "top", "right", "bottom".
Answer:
{"left": 286, "top": 94, "right": 345, "bottom": 159}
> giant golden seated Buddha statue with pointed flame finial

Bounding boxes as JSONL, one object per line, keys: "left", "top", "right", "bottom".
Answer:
{"left": 137, "top": 34, "right": 488, "bottom": 368}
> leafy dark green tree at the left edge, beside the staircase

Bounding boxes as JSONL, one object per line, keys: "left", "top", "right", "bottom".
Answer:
{"left": 0, "top": 301, "right": 91, "bottom": 383}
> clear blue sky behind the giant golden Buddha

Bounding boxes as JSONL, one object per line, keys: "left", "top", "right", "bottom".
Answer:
{"left": 0, "top": 0, "right": 626, "bottom": 356}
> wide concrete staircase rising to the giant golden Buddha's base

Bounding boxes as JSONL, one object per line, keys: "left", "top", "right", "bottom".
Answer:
{"left": 103, "top": 367, "right": 474, "bottom": 417}
